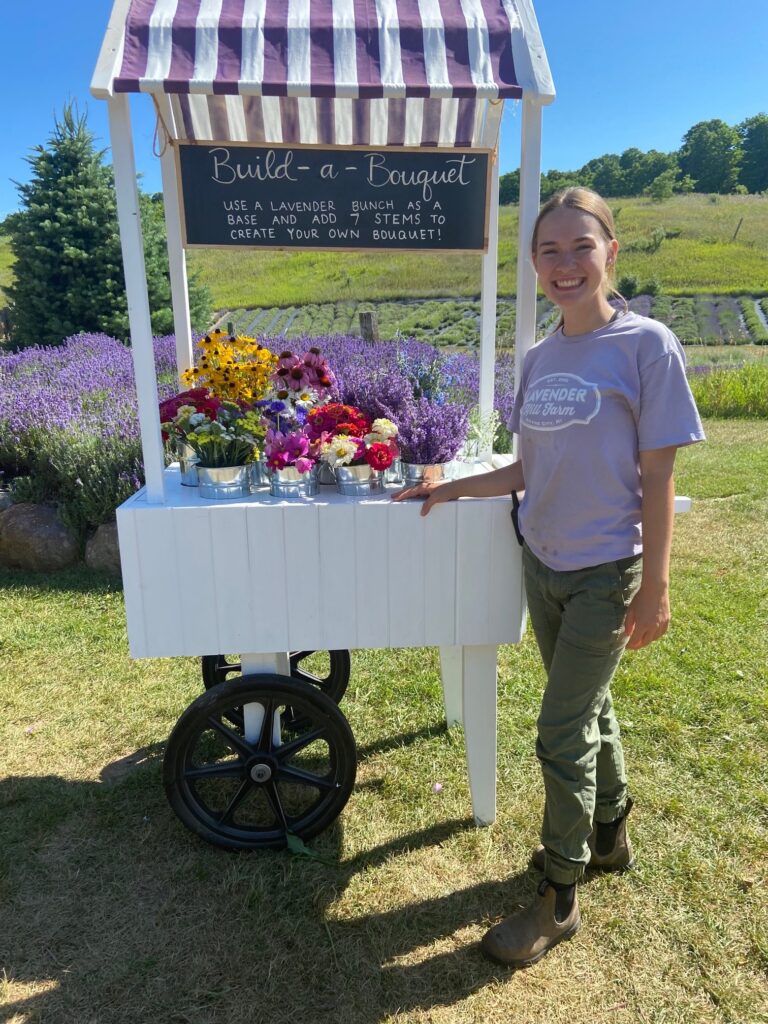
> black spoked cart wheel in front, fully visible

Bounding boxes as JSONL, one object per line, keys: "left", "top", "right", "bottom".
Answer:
{"left": 163, "top": 674, "right": 357, "bottom": 850}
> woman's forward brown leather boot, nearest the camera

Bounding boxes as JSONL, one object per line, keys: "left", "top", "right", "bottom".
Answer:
{"left": 480, "top": 879, "right": 582, "bottom": 967}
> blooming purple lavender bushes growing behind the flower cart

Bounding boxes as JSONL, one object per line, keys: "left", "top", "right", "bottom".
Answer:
{"left": 0, "top": 334, "right": 514, "bottom": 539}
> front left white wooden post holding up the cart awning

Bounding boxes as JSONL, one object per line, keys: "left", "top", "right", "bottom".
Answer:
{"left": 108, "top": 94, "right": 165, "bottom": 504}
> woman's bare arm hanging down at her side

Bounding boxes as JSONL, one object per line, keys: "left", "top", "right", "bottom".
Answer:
{"left": 624, "top": 447, "right": 677, "bottom": 650}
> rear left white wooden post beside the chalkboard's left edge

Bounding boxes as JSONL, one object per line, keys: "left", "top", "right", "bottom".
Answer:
{"left": 155, "top": 93, "right": 195, "bottom": 383}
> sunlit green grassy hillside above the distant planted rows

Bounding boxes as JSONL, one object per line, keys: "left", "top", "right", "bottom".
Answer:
{"left": 0, "top": 196, "right": 768, "bottom": 309}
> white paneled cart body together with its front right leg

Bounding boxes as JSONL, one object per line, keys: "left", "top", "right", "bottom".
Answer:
{"left": 118, "top": 468, "right": 524, "bottom": 824}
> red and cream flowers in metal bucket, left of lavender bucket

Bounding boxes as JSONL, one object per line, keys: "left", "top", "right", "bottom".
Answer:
{"left": 307, "top": 402, "right": 399, "bottom": 495}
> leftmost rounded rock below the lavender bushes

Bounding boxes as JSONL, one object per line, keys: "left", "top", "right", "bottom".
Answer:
{"left": 0, "top": 503, "right": 80, "bottom": 572}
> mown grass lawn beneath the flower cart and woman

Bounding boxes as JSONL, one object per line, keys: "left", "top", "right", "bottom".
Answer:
{"left": 0, "top": 421, "right": 768, "bottom": 1024}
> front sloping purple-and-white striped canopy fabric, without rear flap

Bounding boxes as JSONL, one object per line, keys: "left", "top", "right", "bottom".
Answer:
{"left": 114, "top": 0, "right": 522, "bottom": 99}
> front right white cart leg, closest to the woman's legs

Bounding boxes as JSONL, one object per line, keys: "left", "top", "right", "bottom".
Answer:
{"left": 461, "top": 646, "right": 497, "bottom": 825}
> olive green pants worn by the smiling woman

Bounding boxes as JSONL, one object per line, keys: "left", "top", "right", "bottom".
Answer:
{"left": 523, "top": 546, "right": 642, "bottom": 884}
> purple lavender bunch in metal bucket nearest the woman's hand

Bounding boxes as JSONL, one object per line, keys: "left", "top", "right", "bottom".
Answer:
{"left": 399, "top": 397, "right": 469, "bottom": 483}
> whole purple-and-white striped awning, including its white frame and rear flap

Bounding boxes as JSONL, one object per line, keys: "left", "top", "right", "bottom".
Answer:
{"left": 92, "top": 0, "right": 551, "bottom": 146}
